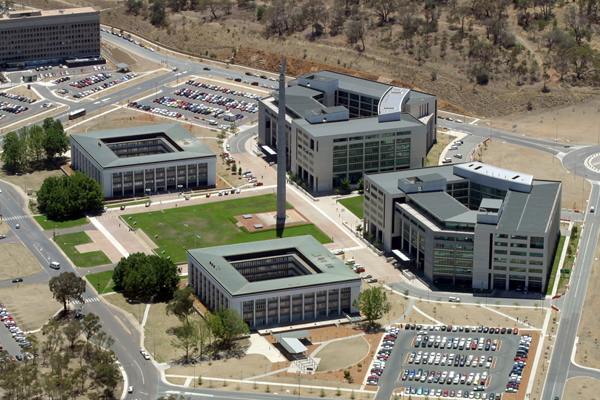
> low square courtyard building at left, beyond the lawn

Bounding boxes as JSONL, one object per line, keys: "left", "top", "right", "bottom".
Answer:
{"left": 70, "top": 124, "right": 216, "bottom": 198}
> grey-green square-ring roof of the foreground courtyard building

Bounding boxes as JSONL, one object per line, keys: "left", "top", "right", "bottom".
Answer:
{"left": 188, "top": 235, "right": 360, "bottom": 296}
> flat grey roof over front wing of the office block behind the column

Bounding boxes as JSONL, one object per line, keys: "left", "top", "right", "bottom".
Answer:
{"left": 294, "top": 113, "right": 424, "bottom": 137}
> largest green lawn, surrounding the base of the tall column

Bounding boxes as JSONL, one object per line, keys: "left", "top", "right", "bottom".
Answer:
{"left": 123, "top": 194, "right": 331, "bottom": 263}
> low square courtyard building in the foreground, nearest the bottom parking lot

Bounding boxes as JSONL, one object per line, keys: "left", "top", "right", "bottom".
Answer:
{"left": 188, "top": 236, "right": 361, "bottom": 328}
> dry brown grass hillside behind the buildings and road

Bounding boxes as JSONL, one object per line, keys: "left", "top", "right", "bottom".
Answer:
{"left": 19, "top": 0, "right": 594, "bottom": 116}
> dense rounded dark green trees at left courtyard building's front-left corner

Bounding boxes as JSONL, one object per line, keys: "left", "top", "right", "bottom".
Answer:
{"left": 37, "top": 172, "right": 104, "bottom": 221}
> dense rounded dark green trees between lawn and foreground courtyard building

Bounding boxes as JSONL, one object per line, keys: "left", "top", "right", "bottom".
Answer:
{"left": 113, "top": 253, "right": 179, "bottom": 301}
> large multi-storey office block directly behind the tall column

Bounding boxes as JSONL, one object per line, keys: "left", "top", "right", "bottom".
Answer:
{"left": 258, "top": 71, "right": 437, "bottom": 193}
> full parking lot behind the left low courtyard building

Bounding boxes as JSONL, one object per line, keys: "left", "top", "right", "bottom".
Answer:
{"left": 129, "top": 79, "right": 260, "bottom": 129}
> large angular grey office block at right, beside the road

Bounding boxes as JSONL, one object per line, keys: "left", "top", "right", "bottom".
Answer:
{"left": 364, "top": 162, "right": 561, "bottom": 292}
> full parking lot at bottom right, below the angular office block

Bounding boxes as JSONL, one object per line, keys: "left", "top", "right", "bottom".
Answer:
{"left": 367, "top": 324, "right": 533, "bottom": 399}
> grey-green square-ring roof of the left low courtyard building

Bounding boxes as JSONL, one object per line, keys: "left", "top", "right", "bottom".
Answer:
{"left": 70, "top": 124, "right": 215, "bottom": 168}
